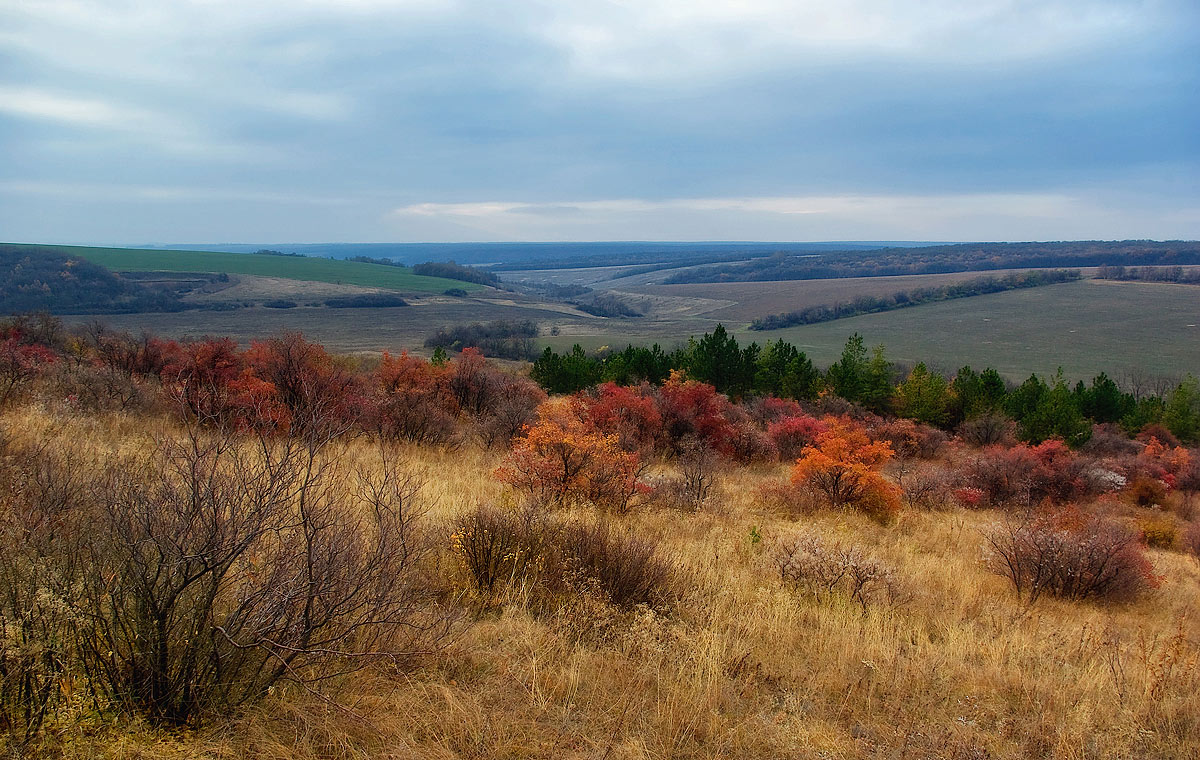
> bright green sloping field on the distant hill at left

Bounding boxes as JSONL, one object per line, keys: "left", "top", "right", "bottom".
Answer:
{"left": 9, "top": 245, "right": 482, "bottom": 293}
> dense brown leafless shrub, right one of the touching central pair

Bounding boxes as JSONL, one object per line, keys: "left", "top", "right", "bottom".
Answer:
{"left": 558, "top": 521, "right": 676, "bottom": 611}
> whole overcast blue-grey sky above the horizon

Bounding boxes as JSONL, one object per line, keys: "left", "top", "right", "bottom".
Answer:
{"left": 0, "top": 0, "right": 1200, "bottom": 245}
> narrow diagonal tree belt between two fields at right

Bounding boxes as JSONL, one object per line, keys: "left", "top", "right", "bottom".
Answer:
{"left": 750, "top": 269, "right": 1080, "bottom": 330}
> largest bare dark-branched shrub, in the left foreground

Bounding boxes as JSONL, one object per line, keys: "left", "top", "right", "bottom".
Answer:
{"left": 70, "top": 435, "right": 451, "bottom": 724}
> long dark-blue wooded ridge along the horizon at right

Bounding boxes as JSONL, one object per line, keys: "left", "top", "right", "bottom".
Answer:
{"left": 665, "top": 240, "right": 1200, "bottom": 283}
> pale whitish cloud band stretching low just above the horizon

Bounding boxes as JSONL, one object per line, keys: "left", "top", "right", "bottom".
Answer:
{"left": 389, "top": 193, "right": 1195, "bottom": 240}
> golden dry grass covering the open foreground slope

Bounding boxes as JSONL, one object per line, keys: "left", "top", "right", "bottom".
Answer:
{"left": 2, "top": 407, "right": 1200, "bottom": 760}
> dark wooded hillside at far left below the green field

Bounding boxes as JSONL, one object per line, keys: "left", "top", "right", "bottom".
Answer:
{"left": 0, "top": 245, "right": 188, "bottom": 315}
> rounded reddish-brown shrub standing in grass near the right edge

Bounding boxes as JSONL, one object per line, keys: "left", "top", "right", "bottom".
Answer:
{"left": 986, "top": 510, "right": 1158, "bottom": 603}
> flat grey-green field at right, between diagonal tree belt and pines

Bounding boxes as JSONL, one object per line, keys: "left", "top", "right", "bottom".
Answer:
{"left": 738, "top": 280, "right": 1200, "bottom": 379}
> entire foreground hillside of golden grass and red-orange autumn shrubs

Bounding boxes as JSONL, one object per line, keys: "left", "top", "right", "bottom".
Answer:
{"left": 0, "top": 319, "right": 1200, "bottom": 759}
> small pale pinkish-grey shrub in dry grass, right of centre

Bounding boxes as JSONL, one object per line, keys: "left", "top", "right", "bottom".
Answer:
{"left": 773, "top": 535, "right": 906, "bottom": 614}
